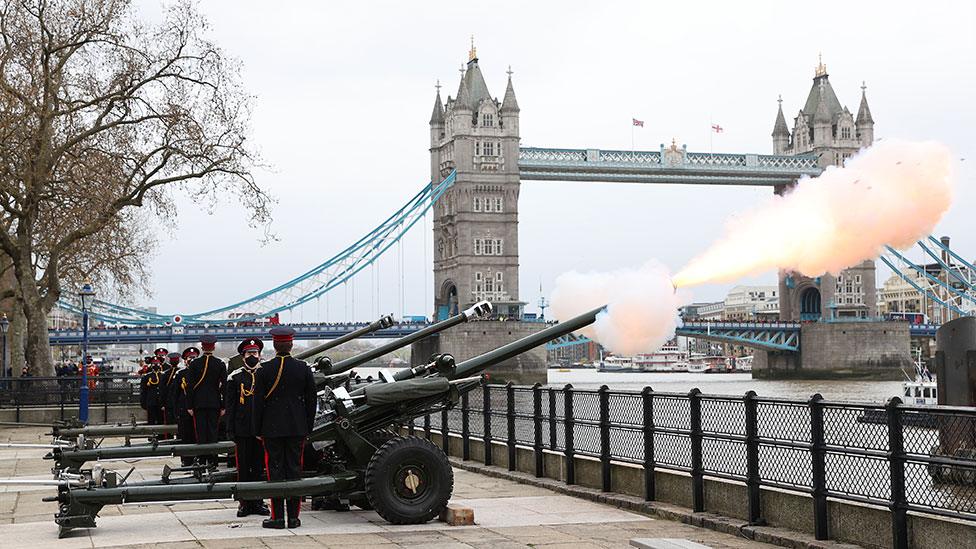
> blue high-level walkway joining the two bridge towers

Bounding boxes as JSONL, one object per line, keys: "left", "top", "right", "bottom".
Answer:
{"left": 519, "top": 145, "right": 823, "bottom": 187}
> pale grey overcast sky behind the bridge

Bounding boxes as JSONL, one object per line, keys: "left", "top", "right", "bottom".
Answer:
{"left": 132, "top": 0, "right": 976, "bottom": 321}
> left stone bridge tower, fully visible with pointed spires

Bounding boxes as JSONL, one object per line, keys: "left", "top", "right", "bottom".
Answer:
{"left": 430, "top": 41, "right": 525, "bottom": 318}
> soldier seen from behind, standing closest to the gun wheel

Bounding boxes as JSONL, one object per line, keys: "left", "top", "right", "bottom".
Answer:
{"left": 254, "top": 327, "right": 316, "bottom": 529}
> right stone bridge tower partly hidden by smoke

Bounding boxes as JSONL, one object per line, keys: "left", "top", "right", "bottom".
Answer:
{"left": 772, "top": 55, "right": 878, "bottom": 321}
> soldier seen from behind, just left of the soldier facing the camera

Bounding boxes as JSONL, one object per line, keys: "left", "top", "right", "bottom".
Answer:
{"left": 186, "top": 335, "right": 227, "bottom": 466}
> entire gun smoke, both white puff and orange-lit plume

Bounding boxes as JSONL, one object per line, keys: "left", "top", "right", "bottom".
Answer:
{"left": 552, "top": 141, "right": 952, "bottom": 355}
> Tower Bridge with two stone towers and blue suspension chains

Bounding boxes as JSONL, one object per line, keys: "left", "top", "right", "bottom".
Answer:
{"left": 55, "top": 47, "right": 972, "bottom": 380}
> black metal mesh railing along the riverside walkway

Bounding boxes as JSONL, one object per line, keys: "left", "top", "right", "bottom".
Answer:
{"left": 409, "top": 384, "right": 976, "bottom": 547}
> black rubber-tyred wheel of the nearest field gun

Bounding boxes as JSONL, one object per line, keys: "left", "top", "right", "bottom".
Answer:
{"left": 366, "top": 437, "right": 454, "bottom": 524}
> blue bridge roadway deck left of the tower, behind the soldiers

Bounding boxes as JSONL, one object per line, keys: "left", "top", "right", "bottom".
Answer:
{"left": 49, "top": 322, "right": 428, "bottom": 345}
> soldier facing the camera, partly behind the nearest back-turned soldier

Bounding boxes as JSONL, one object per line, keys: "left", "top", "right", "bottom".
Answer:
{"left": 224, "top": 338, "right": 270, "bottom": 517}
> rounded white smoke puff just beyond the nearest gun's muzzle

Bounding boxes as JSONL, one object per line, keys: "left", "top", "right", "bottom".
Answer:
{"left": 552, "top": 261, "right": 685, "bottom": 355}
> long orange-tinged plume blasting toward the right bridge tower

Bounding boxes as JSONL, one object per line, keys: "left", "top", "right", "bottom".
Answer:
{"left": 674, "top": 141, "right": 952, "bottom": 287}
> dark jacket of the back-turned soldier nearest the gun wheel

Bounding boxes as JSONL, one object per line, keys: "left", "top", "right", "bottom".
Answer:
{"left": 254, "top": 355, "right": 316, "bottom": 437}
